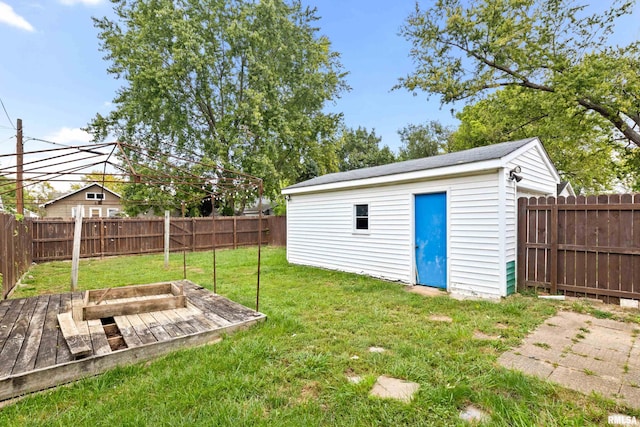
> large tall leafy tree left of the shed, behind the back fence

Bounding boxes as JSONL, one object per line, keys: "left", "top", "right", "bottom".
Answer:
{"left": 88, "top": 0, "right": 347, "bottom": 212}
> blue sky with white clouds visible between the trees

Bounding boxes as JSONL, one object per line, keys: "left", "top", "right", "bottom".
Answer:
{"left": 0, "top": 0, "right": 640, "bottom": 190}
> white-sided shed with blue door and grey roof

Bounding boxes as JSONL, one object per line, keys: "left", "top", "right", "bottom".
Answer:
{"left": 282, "top": 138, "right": 560, "bottom": 298}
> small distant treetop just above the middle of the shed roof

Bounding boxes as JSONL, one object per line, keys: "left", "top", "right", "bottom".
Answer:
{"left": 398, "top": 121, "right": 451, "bottom": 160}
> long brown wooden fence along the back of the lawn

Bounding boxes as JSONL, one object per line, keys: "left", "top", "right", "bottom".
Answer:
{"left": 29, "top": 216, "right": 286, "bottom": 262}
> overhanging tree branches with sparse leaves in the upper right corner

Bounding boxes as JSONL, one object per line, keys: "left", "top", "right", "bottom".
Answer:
{"left": 398, "top": 0, "right": 640, "bottom": 146}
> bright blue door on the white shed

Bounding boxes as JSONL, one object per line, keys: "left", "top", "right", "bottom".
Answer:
{"left": 415, "top": 193, "right": 447, "bottom": 289}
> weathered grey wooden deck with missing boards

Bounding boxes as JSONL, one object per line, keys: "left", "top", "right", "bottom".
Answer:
{"left": 0, "top": 280, "right": 266, "bottom": 401}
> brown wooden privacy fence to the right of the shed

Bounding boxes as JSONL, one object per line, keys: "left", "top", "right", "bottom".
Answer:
{"left": 518, "top": 194, "right": 640, "bottom": 302}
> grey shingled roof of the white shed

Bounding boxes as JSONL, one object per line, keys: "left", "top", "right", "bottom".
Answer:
{"left": 284, "top": 138, "right": 538, "bottom": 190}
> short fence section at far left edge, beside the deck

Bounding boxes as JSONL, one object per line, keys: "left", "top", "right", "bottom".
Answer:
{"left": 0, "top": 213, "right": 32, "bottom": 298}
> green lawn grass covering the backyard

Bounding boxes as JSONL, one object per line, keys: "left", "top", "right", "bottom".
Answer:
{"left": 0, "top": 248, "right": 640, "bottom": 426}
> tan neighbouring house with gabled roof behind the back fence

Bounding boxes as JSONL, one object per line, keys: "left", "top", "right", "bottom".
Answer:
{"left": 42, "top": 182, "right": 123, "bottom": 218}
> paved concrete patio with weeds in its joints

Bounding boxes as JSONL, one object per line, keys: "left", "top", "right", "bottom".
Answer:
{"left": 498, "top": 312, "right": 640, "bottom": 409}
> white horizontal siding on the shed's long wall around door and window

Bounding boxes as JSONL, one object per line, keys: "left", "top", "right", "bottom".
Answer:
{"left": 287, "top": 172, "right": 504, "bottom": 297}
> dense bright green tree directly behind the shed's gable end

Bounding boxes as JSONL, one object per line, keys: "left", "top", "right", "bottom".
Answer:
{"left": 451, "top": 87, "right": 625, "bottom": 193}
